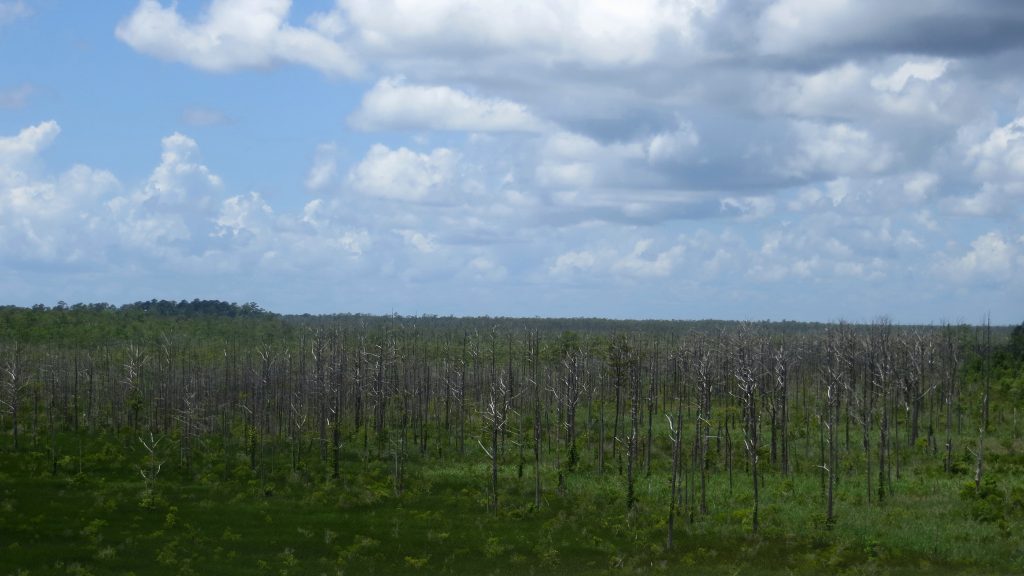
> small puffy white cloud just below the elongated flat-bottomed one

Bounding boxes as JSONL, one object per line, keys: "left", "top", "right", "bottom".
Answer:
{"left": 348, "top": 145, "right": 458, "bottom": 201}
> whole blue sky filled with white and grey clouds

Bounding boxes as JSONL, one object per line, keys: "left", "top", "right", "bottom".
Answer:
{"left": 0, "top": 0, "right": 1024, "bottom": 324}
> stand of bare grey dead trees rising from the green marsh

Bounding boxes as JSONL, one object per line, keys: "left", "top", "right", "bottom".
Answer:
{"left": 0, "top": 309, "right": 1016, "bottom": 546}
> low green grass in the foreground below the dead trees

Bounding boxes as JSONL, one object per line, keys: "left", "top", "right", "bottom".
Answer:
{"left": 0, "top": 432, "right": 1024, "bottom": 575}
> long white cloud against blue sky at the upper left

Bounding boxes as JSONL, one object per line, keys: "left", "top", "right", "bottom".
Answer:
{"left": 116, "top": 0, "right": 359, "bottom": 76}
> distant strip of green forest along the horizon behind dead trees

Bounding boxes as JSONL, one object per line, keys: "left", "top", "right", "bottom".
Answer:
{"left": 0, "top": 298, "right": 1015, "bottom": 344}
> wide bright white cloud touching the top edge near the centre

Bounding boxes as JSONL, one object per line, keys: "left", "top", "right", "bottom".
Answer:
{"left": 344, "top": 0, "right": 718, "bottom": 68}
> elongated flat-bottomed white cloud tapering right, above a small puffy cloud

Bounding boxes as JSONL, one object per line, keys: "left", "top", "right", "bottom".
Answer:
{"left": 349, "top": 77, "right": 545, "bottom": 132}
